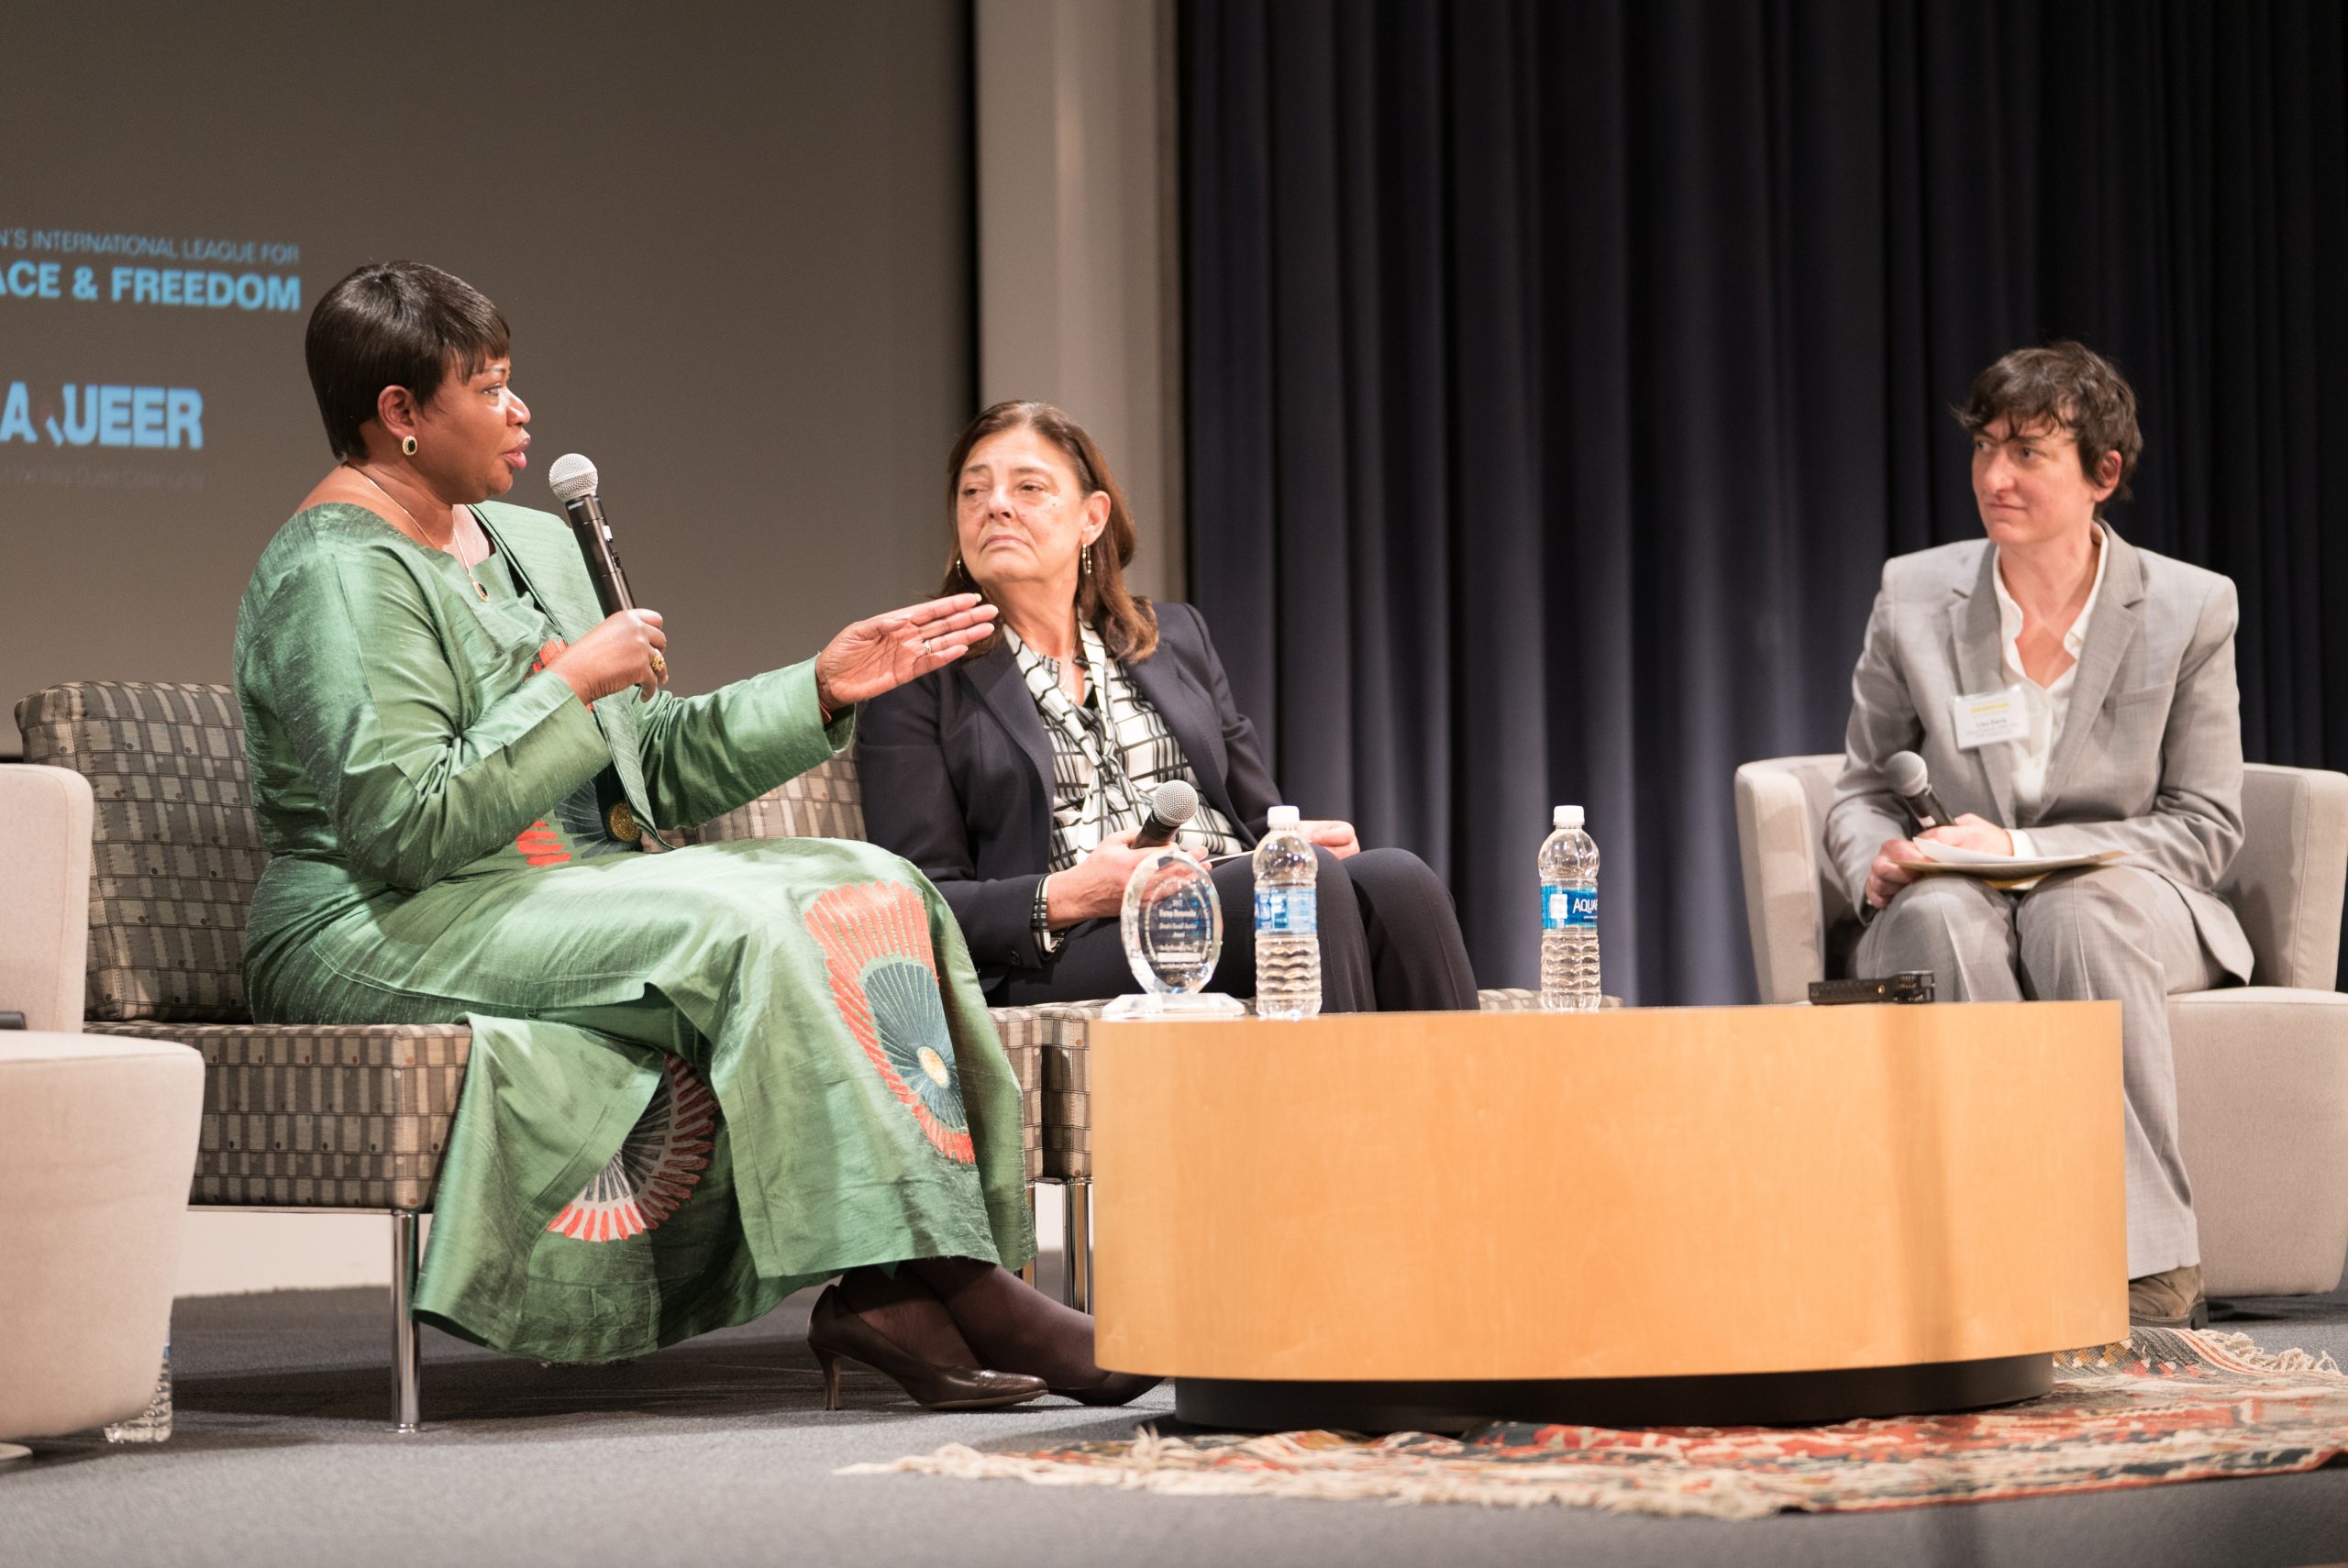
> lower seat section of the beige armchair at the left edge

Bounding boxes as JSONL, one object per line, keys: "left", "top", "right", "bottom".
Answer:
{"left": 0, "top": 1031, "right": 205, "bottom": 1439}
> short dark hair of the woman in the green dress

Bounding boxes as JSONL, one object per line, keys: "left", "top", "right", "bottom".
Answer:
{"left": 303, "top": 260, "right": 515, "bottom": 460}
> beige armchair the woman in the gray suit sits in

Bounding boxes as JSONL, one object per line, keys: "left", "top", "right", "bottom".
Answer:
{"left": 1735, "top": 754, "right": 2348, "bottom": 1296}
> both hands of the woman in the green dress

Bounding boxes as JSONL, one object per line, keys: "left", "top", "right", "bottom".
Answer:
{"left": 547, "top": 594, "right": 995, "bottom": 721}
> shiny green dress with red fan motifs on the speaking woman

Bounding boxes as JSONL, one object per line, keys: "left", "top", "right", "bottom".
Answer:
{"left": 235, "top": 504, "right": 1036, "bottom": 1362}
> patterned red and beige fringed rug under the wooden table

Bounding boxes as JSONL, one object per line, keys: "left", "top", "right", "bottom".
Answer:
{"left": 838, "top": 1329, "right": 2348, "bottom": 1518}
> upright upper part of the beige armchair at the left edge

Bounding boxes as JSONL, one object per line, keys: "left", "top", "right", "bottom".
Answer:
{"left": 0, "top": 763, "right": 92, "bottom": 1035}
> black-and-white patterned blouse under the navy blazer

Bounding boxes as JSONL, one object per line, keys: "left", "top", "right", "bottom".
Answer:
{"left": 1002, "top": 626, "right": 1246, "bottom": 871}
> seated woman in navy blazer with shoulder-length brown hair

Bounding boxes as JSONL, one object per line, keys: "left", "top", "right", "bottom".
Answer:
{"left": 857, "top": 403, "right": 1477, "bottom": 1011}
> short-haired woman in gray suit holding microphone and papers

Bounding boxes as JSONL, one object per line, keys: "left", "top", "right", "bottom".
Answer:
{"left": 1827, "top": 343, "right": 2249, "bottom": 1326}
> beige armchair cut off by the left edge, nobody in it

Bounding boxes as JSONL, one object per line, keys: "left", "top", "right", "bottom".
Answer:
{"left": 0, "top": 767, "right": 205, "bottom": 1458}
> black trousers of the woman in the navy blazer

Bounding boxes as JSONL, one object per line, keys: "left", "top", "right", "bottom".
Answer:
{"left": 989, "top": 850, "right": 1477, "bottom": 1011}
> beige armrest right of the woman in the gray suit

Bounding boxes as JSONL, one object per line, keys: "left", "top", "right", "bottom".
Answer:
{"left": 2219, "top": 763, "right": 2348, "bottom": 990}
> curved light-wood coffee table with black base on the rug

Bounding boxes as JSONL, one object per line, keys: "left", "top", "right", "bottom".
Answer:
{"left": 1091, "top": 1002, "right": 2127, "bottom": 1430}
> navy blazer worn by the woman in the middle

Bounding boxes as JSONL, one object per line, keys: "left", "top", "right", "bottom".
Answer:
{"left": 857, "top": 603, "right": 1279, "bottom": 990}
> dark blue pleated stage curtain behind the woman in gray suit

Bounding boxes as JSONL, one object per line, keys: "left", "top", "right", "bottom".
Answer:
{"left": 1181, "top": 0, "right": 2348, "bottom": 1002}
